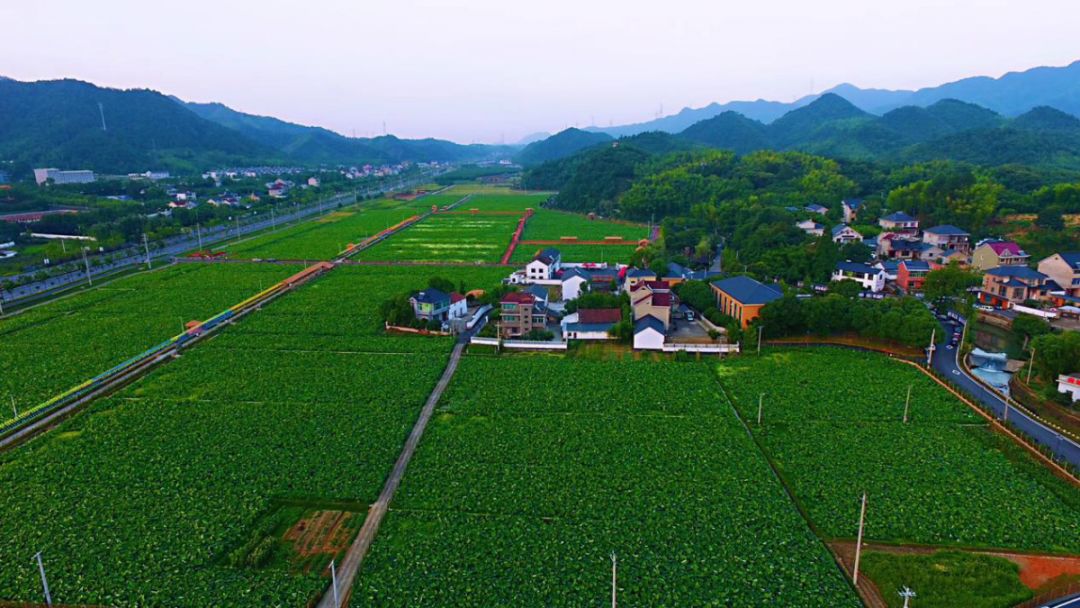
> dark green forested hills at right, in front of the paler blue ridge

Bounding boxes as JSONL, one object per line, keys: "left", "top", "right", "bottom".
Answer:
{"left": 523, "top": 94, "right": 1080, "bottom": 171}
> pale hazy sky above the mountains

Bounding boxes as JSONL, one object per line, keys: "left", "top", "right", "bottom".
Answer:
{"left": 0, "top": 0, "right": 1080, "bottom": 143}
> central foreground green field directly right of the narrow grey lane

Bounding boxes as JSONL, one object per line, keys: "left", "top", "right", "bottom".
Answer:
{"left": 352, "top": 356, "right": 859, "bottom": 607}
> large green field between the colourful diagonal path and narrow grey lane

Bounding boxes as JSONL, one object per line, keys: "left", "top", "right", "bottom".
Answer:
{"left": 0, "top": 265, "right": 511, "bottom": 607}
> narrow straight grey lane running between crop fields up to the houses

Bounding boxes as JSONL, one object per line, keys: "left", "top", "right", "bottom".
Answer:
{"left": 316, "top": 313, "right": 486, "bottom": 608}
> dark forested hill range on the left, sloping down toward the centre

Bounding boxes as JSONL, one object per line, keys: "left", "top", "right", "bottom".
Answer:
{"left": 0, "top": 79, "right": 510, "bottom": 176}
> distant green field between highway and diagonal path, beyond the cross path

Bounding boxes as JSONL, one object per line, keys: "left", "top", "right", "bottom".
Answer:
{"left": 222, "top": 201, "right": 418, "bottom": 260}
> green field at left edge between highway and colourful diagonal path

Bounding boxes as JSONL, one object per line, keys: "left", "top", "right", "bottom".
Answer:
{"left": 0, "top": 264, "right": 301, "bottom": 419}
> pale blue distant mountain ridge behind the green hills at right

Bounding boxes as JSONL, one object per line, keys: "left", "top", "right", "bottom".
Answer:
{"left": 585, "top": 60, "right": 1080, "bottom": 137}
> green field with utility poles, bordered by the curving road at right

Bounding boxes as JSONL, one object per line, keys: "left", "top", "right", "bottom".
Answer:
{"left": 718, "top": 349, "right": 1080, "bottom": 553}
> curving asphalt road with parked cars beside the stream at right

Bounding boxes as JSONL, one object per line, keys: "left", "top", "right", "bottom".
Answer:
{"left": 933, "top": 320, "right": 1080, "bottom": 470}
